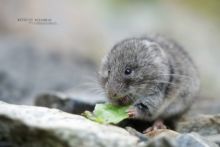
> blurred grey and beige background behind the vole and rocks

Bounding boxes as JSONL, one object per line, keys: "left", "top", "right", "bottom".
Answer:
{"left": 0, "top": 0, "right": 220, "bottom": 112}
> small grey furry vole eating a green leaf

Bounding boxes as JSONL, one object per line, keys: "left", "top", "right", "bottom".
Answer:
{"left": 99, "top": 35, "right": 200, "bottom": 131}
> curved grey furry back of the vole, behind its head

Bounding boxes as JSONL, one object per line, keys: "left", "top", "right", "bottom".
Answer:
{"left": 142, "top": 36, "right": 200, "bottom": 118}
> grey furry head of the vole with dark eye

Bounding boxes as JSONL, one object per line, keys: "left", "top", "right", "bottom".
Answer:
{"left": 99, "top": 38, "right": 169, "bottom": 105}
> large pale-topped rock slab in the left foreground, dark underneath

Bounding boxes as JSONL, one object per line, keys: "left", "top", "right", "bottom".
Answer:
{"left": 0, "top": 102, "right": 141, "bottom": 147}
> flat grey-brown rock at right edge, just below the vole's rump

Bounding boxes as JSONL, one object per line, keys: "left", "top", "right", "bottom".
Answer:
{"left": 176, "top": 114, "right": 220, "bottom": 136}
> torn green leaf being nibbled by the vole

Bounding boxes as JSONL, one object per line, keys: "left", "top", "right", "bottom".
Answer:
{"left": 82, "top": 103, "right": 129, "bottom": 124}
